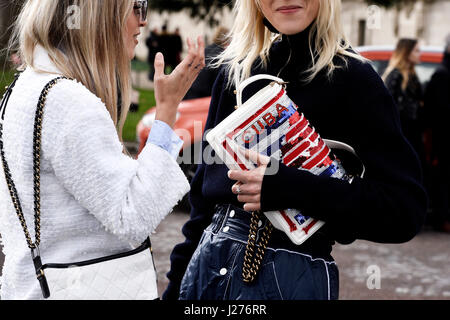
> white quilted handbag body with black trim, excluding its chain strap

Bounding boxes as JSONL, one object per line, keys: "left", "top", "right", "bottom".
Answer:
{"left": 42, "top": 239, "right": 158, "bottom": 300}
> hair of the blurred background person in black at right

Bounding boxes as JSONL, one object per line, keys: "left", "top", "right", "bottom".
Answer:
{"left": 382, "top": 38, "right": 418, "bottom": 90}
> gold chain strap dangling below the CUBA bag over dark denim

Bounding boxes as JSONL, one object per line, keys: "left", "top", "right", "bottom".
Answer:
{"left": 242, "top": 211, "right": 273, "bottom": 283}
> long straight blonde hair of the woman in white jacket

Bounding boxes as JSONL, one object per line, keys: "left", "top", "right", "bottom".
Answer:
{"left": 9, "top": 0, "right": 133, "bottom": 140}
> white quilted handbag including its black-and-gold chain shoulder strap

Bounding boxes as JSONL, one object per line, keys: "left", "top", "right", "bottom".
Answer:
{"left": 0, "top": 76, "right": 158, "bottom": 300}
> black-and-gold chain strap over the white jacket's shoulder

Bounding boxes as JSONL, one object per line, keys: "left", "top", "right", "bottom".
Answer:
{"left": 0, "top": 77, "right": 68, "bottom": 250}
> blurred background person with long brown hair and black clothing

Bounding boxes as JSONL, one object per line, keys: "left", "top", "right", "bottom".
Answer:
{"left": 383, "top": 38, "right": 425, "bottom": 164}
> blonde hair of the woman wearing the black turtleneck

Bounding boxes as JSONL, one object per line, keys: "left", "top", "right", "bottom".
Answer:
{"left": 214, "top": 0, "right": 366, "bottom": 86}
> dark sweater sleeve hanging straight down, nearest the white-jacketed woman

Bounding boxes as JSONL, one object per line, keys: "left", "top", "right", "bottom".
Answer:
{"left": 162, "top": 68, "right": 225, "bottom": 300}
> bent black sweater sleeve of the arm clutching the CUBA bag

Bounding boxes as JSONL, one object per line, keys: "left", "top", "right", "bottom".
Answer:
{"left": 261, "top": 63, "right": 427, "bottom": 243}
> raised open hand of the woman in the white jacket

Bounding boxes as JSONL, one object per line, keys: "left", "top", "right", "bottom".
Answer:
{"left": 154, "top": 36, "right": 205, "bottom": 127}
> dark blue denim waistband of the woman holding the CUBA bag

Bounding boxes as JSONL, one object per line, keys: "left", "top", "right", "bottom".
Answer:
{"left": 207, "top": 204, "right": 333, "bottom": 261}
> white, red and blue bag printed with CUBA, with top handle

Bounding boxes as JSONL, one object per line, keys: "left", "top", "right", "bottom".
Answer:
{"left": 206, "top": 75, "right": 364, "bottom": 245}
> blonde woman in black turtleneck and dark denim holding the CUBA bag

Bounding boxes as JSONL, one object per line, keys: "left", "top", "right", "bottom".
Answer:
{"left": 163, "top": 0, "right": 427, "bottom": 300}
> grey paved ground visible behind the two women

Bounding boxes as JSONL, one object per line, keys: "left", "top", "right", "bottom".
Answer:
{"left": 0, "top": 211, "right": 450, "bottom": 300}
